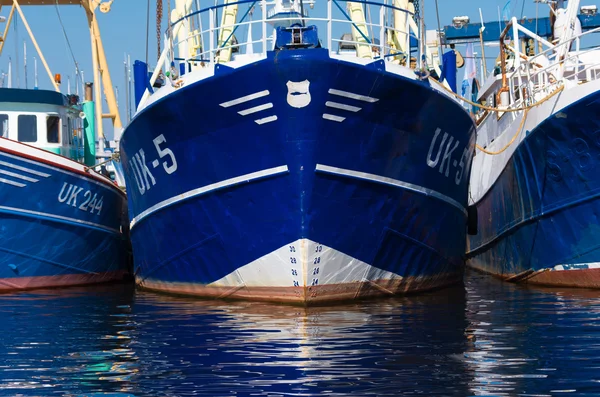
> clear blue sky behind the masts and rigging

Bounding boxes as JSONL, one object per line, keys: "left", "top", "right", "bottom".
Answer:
{"left": 0, "top": 0, "right": 572, "bottom": 121}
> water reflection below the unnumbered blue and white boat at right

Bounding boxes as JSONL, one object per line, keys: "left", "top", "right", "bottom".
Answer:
{"left": 464, "top": 272, "right": 600, "bottom": 396}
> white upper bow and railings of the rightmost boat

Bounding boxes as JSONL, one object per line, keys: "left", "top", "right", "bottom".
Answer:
{"left": 470, "top": 0, "right": 600, "bottom": 203}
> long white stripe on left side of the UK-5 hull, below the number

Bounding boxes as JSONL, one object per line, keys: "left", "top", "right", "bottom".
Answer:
{"left": 130, "top": 165, "right": 288, "bottom": 228}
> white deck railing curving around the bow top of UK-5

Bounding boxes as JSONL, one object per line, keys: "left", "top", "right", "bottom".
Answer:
{"left": 141, "top": 0, "right": 425, "bottom": 103}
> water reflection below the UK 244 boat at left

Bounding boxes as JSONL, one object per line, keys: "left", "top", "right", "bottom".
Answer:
{"left": 0, "top": 284, "right": 138, "bottom": 397}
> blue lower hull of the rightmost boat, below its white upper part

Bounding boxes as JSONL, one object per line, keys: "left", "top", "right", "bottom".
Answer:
{"left": 468, "top": 92, "right": 600, "bottom": 288}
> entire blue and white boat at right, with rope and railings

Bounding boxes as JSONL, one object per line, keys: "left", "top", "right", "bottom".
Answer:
{"left": 467, "top": 0, "right": 600, "bottom": 288}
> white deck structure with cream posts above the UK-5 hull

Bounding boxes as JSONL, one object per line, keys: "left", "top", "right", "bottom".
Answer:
{"left": 137, "top": 0, "right": 452, "bottom": 112}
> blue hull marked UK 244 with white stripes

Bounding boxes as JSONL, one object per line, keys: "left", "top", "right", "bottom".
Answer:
{"left": 0, "top": 139, "right": 130, "bottom": 292}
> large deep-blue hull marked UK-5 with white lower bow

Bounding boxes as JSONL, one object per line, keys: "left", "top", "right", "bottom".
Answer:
{"left": 121, "top": 49, "right": 475, "bottom": 304}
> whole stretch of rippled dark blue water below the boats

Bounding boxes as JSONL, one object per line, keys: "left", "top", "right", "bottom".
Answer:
{"left": 0, "top": 273, "right": 600, "bottom": 397}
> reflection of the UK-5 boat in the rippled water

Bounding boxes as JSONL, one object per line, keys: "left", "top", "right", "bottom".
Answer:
{"left": 127, "top": 287, "right": 468, "bottom": 396}
